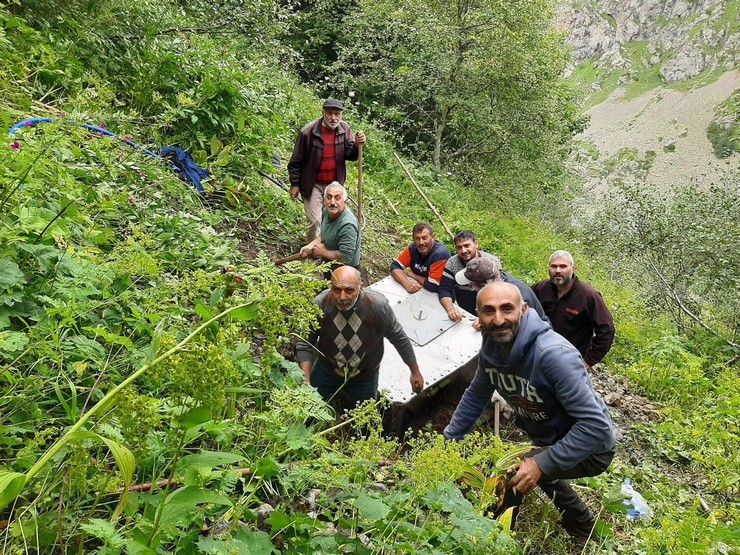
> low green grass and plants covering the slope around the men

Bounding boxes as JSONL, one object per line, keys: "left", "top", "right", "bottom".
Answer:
{"left": 0, "top": 4, "right": 739, "bottom": 555}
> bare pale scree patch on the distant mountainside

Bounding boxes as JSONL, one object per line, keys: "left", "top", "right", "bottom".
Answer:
{"left": 582, "top": 71, "right": 740, "bottom": 192}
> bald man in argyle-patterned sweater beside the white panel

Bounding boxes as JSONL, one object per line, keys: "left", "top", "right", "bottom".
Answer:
{"left": 296, "top": 266, "right": 424, "bottom": 408}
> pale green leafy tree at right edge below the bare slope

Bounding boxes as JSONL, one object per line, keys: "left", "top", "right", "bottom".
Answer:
{"left": 583, "top": 183, "right": 740, "bottom": 349}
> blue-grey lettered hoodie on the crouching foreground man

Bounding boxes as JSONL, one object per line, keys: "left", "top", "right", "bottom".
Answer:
{"left": 444, "top": 310, "right": 615, "bottom": 474}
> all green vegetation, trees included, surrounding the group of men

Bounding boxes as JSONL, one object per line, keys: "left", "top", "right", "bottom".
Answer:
{"left": 0, "top": 0, "right": 740, "bottom": 555}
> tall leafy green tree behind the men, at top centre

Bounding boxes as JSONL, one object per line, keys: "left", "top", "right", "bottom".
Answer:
{"left": 332, "top": 0, "right": 577, "bottom": 180}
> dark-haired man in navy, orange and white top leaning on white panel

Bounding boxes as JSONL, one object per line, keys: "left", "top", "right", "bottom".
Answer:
{"left": 391, "top": 222, "right": 450, "bottom": 293}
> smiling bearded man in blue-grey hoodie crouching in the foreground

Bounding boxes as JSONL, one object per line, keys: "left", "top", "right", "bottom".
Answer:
{"left": 444, "top": 282, "right": 615, "bottom": 537}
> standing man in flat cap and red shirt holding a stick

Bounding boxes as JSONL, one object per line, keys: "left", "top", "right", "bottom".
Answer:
{"left": 288, "top": 98, "right": 365, "bottom": 241}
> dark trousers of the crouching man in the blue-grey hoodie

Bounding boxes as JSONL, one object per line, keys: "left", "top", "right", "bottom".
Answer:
{"left": 500, "top": 447, "right": 614, "bottom": 526}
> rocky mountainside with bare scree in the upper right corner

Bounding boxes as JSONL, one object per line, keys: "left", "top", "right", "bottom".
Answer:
{"left": 556, "top": 0, "right": 740, "bottom": 196}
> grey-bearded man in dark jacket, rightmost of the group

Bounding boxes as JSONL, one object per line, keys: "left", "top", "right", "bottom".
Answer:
{"left": 532, "top": 251, "right": 614, "bottom": 368}
